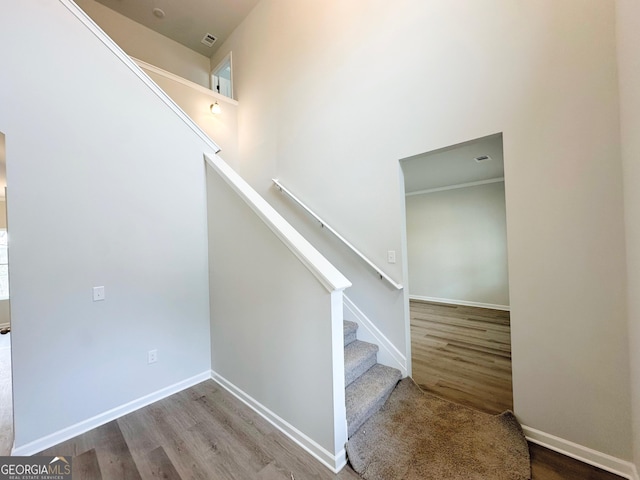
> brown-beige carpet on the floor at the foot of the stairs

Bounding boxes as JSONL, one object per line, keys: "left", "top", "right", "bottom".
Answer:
{"left": 347, "top": 378, "right": 531, "bottom": 480}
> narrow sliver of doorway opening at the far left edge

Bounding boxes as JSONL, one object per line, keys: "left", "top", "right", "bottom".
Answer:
{"left": 0, "top": 132, "right": 13, "bottom": 455}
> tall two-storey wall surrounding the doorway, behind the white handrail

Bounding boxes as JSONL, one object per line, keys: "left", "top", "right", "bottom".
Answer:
{"left": 212, "top": 0, "right": 631, "bottom": 460}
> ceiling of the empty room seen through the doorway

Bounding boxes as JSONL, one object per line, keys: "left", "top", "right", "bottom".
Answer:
{"left": 402, "top": 134, "right": 504, "bottom": 193}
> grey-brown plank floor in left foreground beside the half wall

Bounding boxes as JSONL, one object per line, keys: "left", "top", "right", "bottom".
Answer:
{"left": 41, "top": 380, "right": 360, "bottom": 480}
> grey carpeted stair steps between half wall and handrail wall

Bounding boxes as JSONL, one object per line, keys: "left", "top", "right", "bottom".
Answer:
{"left": 344, "top": 320, "right": 402, "bottom": 437}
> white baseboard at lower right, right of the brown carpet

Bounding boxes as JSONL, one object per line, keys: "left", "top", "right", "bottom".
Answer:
{"left": 522, "top": 425, "right": 640, "bottom": 480}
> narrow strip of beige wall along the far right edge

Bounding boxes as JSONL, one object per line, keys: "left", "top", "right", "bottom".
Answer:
{"left": 616, "top": 0, "right": 640, "bottom": 471}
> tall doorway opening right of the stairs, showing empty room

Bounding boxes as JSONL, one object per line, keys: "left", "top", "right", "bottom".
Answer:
{"left": 401, "top": 134, "right": 513, "bottom": 413}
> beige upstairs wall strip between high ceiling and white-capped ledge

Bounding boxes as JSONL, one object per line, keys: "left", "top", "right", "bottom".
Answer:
{"left": 76, "top": 0, "right": 210, "bottom": 87}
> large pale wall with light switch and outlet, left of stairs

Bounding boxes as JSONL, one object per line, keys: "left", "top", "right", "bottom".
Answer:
{"left": 0, "top": 0, "right": 211, "bottom": 449}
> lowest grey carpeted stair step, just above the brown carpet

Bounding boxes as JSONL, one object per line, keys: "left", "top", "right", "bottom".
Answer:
{"left": 345, "top": 364, "right": 402, "bottom": 437}
